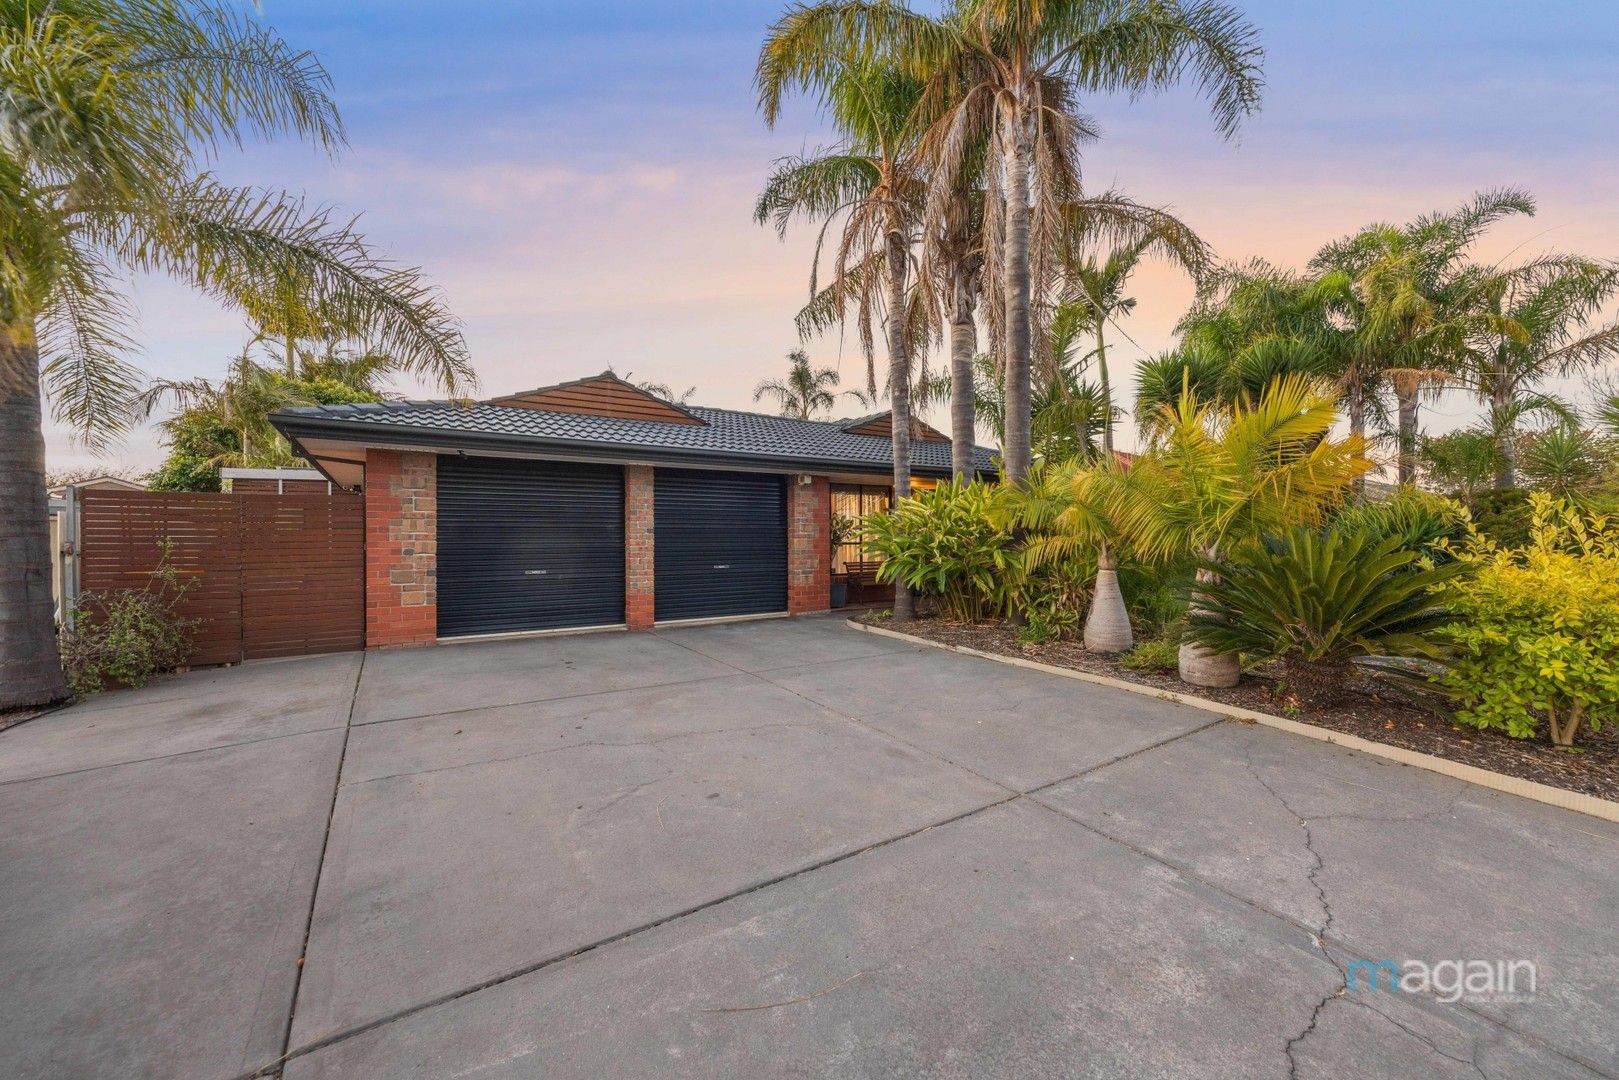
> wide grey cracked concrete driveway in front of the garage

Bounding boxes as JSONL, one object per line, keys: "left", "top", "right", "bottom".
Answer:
{"left": 0, "top": 619, "right": 1619, "bottom": 1080}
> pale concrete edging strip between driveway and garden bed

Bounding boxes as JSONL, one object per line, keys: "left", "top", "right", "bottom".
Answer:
{"left": 845, "top": 619, "right": 1619, "bottom": 823}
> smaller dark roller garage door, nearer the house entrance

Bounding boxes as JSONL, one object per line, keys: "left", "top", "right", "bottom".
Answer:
{"left": 652, "top": 470, "right": 787, "bottom": 620}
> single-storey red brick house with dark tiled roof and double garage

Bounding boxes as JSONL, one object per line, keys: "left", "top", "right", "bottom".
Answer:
{"left": 270, "top": 372, "right": 992, "bottom": 648}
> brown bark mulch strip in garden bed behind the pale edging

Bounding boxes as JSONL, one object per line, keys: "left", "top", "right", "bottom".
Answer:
{"left": 866, "top": 612, "right": 1619, "bottom": 800}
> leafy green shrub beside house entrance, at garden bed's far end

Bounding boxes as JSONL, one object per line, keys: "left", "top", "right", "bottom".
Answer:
{"left": 865, "top": 481, "right": 1022, "bottom": 622}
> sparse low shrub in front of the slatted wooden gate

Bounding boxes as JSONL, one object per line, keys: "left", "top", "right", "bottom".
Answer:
{"left": 60, "top": 542, "right": 196, "bottom": 696}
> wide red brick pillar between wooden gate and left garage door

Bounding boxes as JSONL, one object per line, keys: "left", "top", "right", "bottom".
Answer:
{"left": 366, "top": 450, "right": 439, "bottom": 649}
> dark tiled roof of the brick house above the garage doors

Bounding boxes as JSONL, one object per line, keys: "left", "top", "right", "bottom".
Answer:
{"left": 270, "top": 376, "right": 994, "bottom": 476}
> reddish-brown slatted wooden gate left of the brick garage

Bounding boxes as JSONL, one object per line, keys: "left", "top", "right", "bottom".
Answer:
{"left": 78, "top": 489, "right": 366, "bottom": 665}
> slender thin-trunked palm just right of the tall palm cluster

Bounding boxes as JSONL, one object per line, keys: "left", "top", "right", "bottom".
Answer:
{"left": 1056, "top": 214, "right": 1208, "bottom": 458}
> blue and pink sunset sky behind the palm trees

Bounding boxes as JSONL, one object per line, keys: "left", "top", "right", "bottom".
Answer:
{"left": 47, "top": 0, "right": 1619, "bottom": 468}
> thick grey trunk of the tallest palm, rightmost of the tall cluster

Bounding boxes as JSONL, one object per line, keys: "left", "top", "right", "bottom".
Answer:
{"left": 1001, "top": 104, "right": 1033, "bottom": 483}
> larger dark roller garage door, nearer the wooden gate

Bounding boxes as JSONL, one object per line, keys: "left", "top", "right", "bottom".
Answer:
{"left": 439, "top": 455, "right": 623, "bottom": 636}
